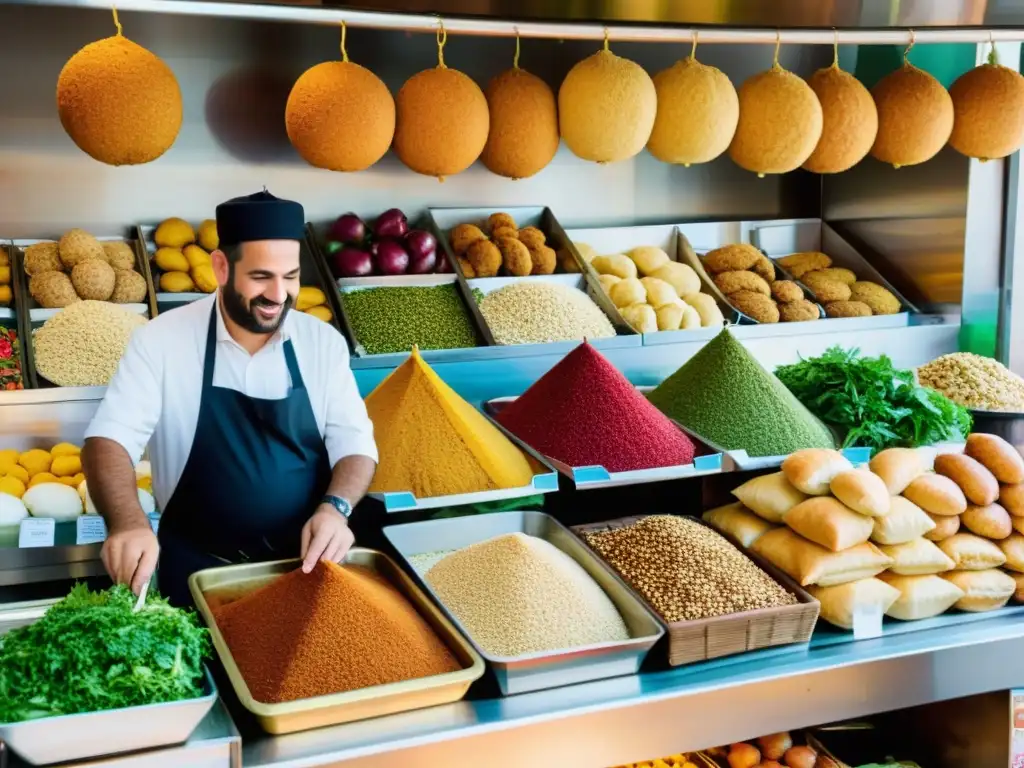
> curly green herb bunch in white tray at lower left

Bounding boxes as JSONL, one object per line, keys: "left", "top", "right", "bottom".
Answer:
{"left": 0, "top": 584, "right": 210, "bottom": 723}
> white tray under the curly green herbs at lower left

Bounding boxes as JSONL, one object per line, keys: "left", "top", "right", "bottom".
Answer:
{"left": 0, "top": 600, "right": 217, "bottom": 765}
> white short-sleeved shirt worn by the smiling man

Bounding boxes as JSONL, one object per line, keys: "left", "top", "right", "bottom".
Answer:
{"left": 85, "top": 293, "right": 377, "bottom": 509}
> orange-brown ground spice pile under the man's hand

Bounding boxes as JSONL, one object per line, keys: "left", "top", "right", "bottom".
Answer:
{"left": 214, "top": 562, "right": 460, "bottom": 703}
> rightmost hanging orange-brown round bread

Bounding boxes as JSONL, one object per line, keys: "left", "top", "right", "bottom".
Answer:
{"left": 949, "top": 46, "right": 1024, "bottom": 160}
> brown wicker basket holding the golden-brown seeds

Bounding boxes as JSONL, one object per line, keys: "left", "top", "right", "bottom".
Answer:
{"left": 572, "top": 515, "right": 821, "bottom": 667}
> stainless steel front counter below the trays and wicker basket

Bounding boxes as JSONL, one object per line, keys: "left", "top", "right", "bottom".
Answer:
{"left": 240, "top": 616, "right": 1024, "bottom": 768}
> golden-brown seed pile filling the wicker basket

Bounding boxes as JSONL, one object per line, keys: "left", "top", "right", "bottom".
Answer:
{"left": 584, "top": 515, "right": 797, "bottom": 624}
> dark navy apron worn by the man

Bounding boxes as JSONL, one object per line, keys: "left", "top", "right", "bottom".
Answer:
{"left": 157, "top": 303, "right": 331, "bottom": 607}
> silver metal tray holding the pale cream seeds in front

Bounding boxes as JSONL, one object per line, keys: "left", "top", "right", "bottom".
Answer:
{"left": 384, "top": 512, "right": 665, "bottom": 695}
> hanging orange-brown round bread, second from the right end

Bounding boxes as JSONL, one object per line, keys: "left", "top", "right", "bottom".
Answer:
{"left": 871, "top": 57, "right": 953, "bottom": 168}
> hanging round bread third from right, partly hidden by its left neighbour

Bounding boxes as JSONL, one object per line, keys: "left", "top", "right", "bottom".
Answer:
{"left": 804, "top": 58, "right": 879, "bottom": 173}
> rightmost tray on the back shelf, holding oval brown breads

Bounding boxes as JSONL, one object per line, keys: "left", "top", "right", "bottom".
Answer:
{"left": 750, "top": 218, "right": 918, "bottom": 331}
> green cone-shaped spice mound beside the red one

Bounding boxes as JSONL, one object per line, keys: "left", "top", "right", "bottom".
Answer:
{"left": 648, "top": 330, "right": 836, "bottom": 456}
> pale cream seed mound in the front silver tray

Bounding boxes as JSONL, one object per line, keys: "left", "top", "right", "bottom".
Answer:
{"left": 426, "top": 534, "right": 630, "bottom": 657}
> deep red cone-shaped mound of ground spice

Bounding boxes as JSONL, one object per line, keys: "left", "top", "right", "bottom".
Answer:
{"left": 498, "top": 342, "right": 694, "bottom": 472}
